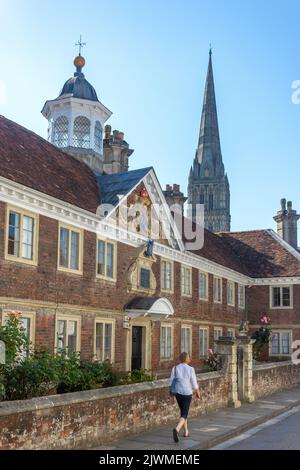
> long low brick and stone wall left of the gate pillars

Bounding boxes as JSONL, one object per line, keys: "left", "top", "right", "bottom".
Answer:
{"left": 0, "top": 371, "right": 228, "bottom": 450}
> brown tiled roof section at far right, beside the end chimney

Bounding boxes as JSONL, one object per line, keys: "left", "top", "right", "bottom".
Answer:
{"left": 218, "top": 230, "right": 300, "bottom": 278}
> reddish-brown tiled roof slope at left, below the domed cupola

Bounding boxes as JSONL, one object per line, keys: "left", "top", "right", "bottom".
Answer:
{"left": 0, "top": 116, "right": 100, "bottom": 213}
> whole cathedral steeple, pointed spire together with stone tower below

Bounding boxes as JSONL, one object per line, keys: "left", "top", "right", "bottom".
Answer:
{"left": 188, "top": 49, "right": 230, "bottom": 232}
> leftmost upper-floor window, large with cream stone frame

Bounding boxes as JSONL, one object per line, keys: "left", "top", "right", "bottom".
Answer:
{"left": 5, "top": 206, "right": 39, "bottom": 265}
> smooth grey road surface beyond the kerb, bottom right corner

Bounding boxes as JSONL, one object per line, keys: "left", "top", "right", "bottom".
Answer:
{"left": 213, "top": 406, "right": 300, "bottom": 450}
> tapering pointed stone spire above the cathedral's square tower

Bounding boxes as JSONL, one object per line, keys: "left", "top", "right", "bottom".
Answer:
{"left": 197, "top": 48, "right": 224, "bottom": 177}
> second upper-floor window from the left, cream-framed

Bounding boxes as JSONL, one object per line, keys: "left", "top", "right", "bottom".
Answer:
{"left": 58, "top": 223, "right": 83, "bottom": 274}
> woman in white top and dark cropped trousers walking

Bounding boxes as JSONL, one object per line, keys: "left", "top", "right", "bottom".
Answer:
{"left": 170, "top": 352, "right": 200, "bottom": 442}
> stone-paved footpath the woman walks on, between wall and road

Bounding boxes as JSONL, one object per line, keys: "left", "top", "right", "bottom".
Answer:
{"left": 95, "top": 386, "right": 300, "bottom": 451}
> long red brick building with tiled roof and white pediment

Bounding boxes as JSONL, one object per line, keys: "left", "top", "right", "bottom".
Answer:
{"left": 0, "top": 112, "right": 300, "bottom": 371}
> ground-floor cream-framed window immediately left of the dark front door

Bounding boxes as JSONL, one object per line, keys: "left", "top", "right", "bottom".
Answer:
{"left": 94, "top": 318, "right": 115, "bottom": 364}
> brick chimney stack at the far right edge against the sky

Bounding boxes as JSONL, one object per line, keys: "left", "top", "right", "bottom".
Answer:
{"left": 273, "top": 199, "right": 300, "bottom": 250}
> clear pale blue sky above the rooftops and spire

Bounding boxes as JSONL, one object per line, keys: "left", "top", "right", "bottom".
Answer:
{"left": 0, "top": 0, "right": 300, "bottom": 230}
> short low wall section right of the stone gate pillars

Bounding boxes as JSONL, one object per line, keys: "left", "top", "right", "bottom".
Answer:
{"left": 252, "top": 361, "right": 300, "bottom": 399}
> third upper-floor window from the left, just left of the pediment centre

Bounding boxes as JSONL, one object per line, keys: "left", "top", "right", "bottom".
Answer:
{"left": 96, "top": 239, "right": 117, "bottom": 281}
